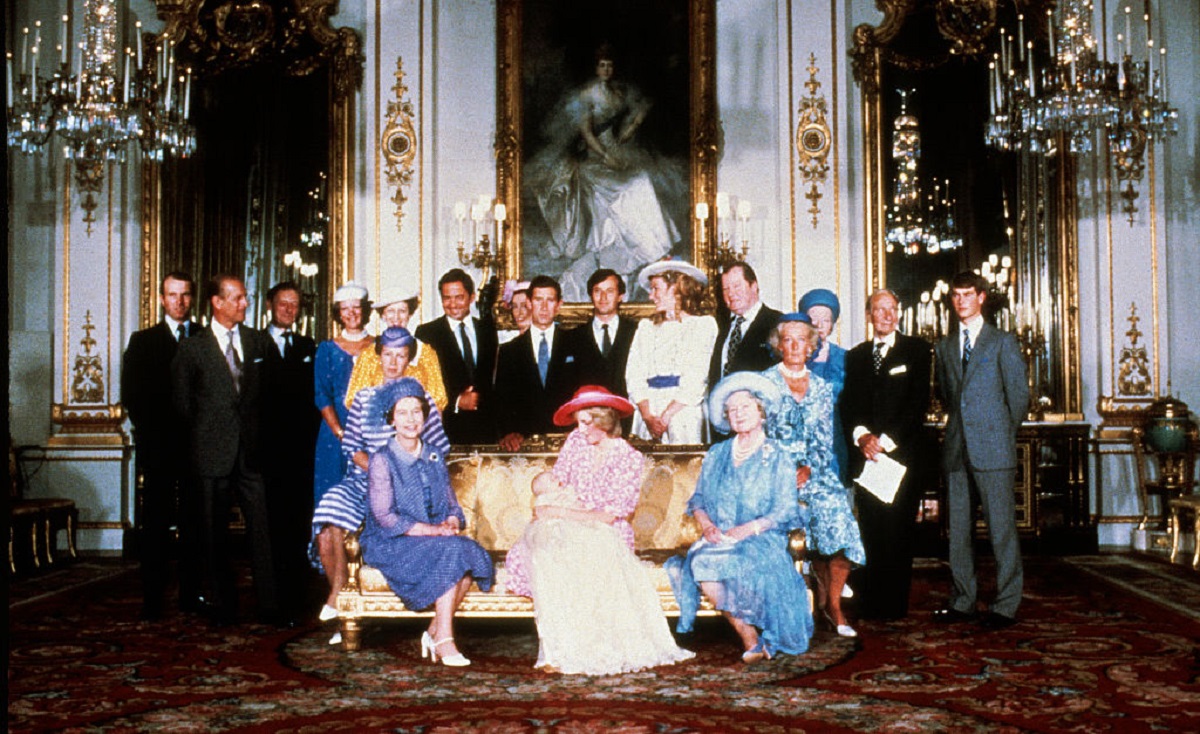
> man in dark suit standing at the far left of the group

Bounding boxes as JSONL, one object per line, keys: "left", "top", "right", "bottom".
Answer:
{"left": 121, "top": 272, "right": 199, "bottom": 620}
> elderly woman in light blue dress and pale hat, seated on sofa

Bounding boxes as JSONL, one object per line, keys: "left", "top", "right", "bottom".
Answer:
{"left": 666, "top": 372, "right": 812, "bottom": 663}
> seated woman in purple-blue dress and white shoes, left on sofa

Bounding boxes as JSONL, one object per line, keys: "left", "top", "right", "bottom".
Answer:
{"left": 361, "top": 378, "right": 493, "bottom": 667}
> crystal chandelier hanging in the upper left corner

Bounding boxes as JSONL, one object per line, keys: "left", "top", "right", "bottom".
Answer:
{"left": 6, "top": 0, "right": 196, "bottom": 235}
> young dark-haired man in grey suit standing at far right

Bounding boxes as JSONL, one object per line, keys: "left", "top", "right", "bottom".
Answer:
{"left": 934, "top": 272, "right": 1030, "bottom": 630}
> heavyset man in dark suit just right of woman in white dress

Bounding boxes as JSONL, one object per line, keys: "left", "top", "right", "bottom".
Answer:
{"left": 708, "top": 261, "right": 782, "bottom": 440}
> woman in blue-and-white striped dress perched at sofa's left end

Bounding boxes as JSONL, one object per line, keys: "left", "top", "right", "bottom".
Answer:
{"left": 312, "top": 326, "right": 450, "bottom": 621}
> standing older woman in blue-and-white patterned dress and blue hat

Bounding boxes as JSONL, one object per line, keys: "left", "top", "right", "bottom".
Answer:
{"left": 762, "top": 313, "right": 866, "bottom": 637}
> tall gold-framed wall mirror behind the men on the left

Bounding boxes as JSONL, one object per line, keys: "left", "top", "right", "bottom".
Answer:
{"left": 143, "top": 0, "right": 365, "bottom": 338}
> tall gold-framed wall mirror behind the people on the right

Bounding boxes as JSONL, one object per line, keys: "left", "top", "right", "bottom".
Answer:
{"left": 853, "top": 0, "right": 1081, "bottom": 416}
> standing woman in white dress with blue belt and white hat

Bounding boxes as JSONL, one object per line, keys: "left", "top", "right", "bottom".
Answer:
{"left": 625, "top": 260, "right": 716, "bottom": 444}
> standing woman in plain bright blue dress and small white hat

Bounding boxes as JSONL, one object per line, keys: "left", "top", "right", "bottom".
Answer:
{"left": 312, "top": 282, "right": 372, "bottom": 506}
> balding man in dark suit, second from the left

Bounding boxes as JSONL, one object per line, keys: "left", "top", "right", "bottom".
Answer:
{"left": 172, "top": 275, "right": 280, "bottom": 624}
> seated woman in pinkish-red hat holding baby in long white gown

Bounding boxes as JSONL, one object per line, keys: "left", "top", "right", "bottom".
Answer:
{"left": 505, "top": 385, "right": 692, "bottom": 675}
